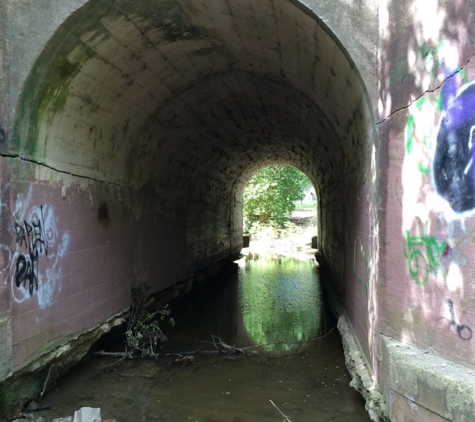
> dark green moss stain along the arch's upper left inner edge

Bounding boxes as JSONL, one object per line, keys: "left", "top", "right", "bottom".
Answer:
{"left": 10, "top": 0, "right": 205, "bottom": 161}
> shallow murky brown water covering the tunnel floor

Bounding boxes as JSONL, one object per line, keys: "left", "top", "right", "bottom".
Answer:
{"left": 38, "top": 256, "right": 369, "bottom": 422}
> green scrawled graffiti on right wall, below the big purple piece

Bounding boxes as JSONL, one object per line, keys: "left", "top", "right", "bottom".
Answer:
{"left": 403, "top": 218, "right": 450, "bottom": 286}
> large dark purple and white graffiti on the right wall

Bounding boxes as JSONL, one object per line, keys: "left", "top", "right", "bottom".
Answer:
{"left": 405, "top": 41, "right": 475, "bottom": 213}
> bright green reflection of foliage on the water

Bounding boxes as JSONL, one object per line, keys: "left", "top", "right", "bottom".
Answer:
{"left": 239, "top": 256, "right": 322, "bottom": 351}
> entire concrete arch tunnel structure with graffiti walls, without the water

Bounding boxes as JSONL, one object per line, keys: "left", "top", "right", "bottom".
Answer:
{"left": 6, "top": 0, "right": 475, "bottom": 422}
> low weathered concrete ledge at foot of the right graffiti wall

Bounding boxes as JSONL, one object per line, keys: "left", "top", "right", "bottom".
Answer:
{"left": 381, "top": 335, "right": 475, "bottom": 422}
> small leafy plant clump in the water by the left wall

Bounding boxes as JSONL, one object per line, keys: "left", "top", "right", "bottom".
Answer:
{"left": 125, "top": 284, "right": 175, "bottom": 357}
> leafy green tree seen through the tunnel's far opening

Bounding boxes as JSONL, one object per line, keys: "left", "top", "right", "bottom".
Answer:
{"left": 243, "top": 165, "right": 312, "bottom": 231}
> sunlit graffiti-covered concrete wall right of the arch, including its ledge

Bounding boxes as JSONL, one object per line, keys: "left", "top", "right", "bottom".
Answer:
{"left": 378, "top": 1, "right": 475, "bottom": 421}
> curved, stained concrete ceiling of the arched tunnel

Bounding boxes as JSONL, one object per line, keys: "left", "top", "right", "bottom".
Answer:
{"left": 12, "top": 0, "right": 369, "bottom": 201}
